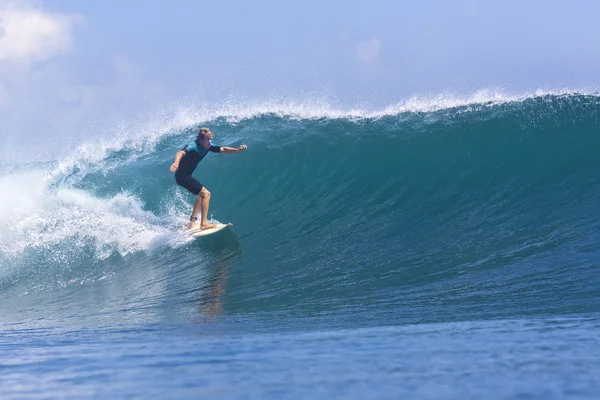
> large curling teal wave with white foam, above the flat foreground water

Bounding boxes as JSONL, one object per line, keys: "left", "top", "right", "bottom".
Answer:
{"left": 0, "top": 94, "right": 600, "bottom": 323}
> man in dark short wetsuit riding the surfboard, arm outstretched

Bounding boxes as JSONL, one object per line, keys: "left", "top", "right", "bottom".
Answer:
{"left": 171, "top": 128, "right": 247, "bottom": 230}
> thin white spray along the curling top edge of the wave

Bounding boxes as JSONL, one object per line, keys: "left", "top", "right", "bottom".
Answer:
{"left": 43, "top": 89, "right": 600, "bottom": 183}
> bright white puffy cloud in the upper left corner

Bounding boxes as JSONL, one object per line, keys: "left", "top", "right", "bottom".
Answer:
{"left": 0, "top": 6, "right": 83, "bottom": 63}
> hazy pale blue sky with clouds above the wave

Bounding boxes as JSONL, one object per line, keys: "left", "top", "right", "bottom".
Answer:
{"left": 0, "top": 0, "right": 600, "bottom": 161}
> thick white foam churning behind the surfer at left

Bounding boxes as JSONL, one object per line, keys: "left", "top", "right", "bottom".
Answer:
{"left": 0, "top": 171, "right": 189, "bottom": 266}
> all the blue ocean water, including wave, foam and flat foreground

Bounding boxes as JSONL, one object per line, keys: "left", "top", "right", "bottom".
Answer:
{"left": 0, "top": 93, "right": 600, "bottom": 399}
